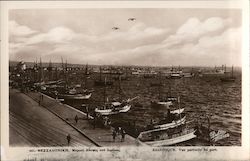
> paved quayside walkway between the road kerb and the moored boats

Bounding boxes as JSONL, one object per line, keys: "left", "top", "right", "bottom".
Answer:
{"left": 27, "top": 92, "right": 145, "bottom": 146}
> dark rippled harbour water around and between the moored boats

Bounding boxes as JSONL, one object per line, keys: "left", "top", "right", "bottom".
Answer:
{"left": 64, "top": 72, "right": 242, "bottom": 146}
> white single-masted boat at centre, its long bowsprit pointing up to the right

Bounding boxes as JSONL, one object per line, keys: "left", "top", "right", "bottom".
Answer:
{"left": 95, "top": 78, "right": 137, "bottom": 115}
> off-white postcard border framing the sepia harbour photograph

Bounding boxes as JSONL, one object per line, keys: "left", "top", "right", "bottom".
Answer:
{"left": 1, "top": 0, "right": 250, "bottom": 160}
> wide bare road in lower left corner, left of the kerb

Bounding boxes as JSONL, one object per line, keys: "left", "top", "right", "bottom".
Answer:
{"left": 9, "top": 89, "right": 95, "bottom": 147}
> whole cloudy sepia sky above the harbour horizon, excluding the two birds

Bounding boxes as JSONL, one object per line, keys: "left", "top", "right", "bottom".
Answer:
{"left": 9, "top": 8, "right": 241, "bottom": 66}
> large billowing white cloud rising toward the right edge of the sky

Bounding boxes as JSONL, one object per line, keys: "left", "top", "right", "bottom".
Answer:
{"left": 158, "top": 27, "right": 241, "bottom": 66}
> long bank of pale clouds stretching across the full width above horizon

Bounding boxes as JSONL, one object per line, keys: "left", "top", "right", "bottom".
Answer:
{"left": 10, "top": 17, "right": 241, "bottom": 66}
